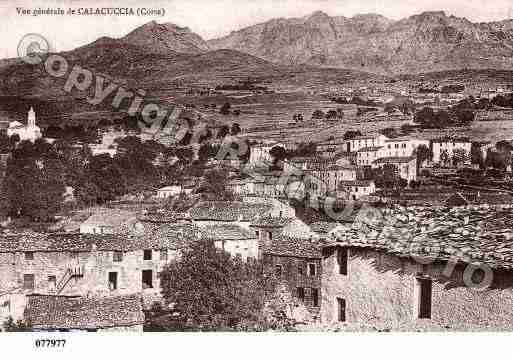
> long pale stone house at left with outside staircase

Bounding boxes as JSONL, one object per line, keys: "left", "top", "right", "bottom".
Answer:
{"left": 0, "top": 223, "right": 202, "bottom": 318}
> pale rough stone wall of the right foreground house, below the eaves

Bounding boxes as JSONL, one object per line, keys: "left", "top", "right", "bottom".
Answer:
{"left": 321, "top": 248, "right": 513, "bottom": 330}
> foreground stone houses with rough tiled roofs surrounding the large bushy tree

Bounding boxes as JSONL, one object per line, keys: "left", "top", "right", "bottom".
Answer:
{"left": 5, "top": 197, "right": 513, "bottom": 331}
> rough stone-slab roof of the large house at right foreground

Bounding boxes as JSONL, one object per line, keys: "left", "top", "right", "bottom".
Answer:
{"left": 331, "top": 206, "right": 513, "bottom": 269}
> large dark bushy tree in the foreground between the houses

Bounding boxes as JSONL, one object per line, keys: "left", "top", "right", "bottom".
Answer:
{"left": 159, "top": 240, "right": 276, "bottom": 330}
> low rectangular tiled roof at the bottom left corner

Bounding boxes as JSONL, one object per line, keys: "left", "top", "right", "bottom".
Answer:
{"left": 25, "top": 295, "right": 144, "bottom": 330}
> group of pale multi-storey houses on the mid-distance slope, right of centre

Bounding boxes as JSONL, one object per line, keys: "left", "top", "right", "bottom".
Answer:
{"left": 236, "top": 135, "right": 476, "bottom": 204}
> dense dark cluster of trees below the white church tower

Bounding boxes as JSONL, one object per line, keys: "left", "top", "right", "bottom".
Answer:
{"left": 0, "top": 126, "right": 248, "bottom": 222}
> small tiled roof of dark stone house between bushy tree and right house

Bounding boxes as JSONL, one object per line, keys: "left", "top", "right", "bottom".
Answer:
{"left": 261, "top": 235, "right": 322, "bottom": 259}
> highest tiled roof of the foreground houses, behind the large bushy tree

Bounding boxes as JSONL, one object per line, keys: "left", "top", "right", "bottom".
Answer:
{"left": 189, "top": 201, "right": 272, "bottom": 221}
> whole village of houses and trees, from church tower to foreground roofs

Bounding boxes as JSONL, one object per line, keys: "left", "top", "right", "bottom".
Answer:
{"left": 0, "top": 86, "right": 513, "bottom": 331}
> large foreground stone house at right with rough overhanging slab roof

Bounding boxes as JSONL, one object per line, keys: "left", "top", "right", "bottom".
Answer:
{"left": 321, "top": 208, "right": 513, "bottom": 330}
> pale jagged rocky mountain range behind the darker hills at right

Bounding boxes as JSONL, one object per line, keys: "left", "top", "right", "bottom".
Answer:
{"left": 208, "top": 12, "right": 513, "bottom": 74}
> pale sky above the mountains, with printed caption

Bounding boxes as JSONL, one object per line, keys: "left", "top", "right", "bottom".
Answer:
{"left": 0, "top": 0, "right": 513, "bottom": 58}
